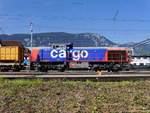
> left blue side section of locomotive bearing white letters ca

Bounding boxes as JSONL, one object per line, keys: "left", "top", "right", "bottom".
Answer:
{"left": 39, "top": 49, "right": 67, "bottom": 62}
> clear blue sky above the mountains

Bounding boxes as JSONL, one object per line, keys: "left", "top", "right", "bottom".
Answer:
{"left": 0, "top": 0, "right": 150, "bottom": 43}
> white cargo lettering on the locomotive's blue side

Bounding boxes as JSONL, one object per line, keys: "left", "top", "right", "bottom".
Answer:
{"left": 50, "top": 49, "right": 89, "bottom": 60}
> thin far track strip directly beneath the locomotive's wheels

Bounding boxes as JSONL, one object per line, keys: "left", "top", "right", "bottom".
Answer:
{"left": 0, "top": 70, "right": 150, "bottom": 75}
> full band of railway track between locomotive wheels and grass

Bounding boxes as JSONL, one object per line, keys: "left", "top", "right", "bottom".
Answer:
{"left": 0, "top": 71, "right": 150, "bottom": 81}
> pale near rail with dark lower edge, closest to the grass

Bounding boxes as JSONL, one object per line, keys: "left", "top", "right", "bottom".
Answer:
{"left": 0, "top": 74, "right": 150, "bottom": 81}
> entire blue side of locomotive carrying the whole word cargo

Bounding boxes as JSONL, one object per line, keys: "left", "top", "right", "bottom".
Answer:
{"left": 37, "top": 49, "right": 106, "bottom": 62}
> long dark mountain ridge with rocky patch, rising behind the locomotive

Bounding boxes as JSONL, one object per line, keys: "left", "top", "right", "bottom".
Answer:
{"left": 0, "top": 32, "right": 115, "bottom": 47}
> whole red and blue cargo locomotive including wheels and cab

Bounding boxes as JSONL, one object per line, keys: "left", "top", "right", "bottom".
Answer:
{"left": 30, "top": 44, "right": 130, "bottom": 71}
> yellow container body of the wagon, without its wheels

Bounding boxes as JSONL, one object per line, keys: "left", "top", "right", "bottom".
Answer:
{"left": 0, "top": 46, "right": 24, "bottom": 63}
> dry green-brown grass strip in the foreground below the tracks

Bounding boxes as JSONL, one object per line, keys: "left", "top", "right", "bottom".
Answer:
{"left": 0, "top": 79, "right": 150, "bottom": 113}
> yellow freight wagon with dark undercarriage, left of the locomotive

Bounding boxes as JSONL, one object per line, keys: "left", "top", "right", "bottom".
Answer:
{"left": 0, "top": 41, "right": 24, "bottom": 71}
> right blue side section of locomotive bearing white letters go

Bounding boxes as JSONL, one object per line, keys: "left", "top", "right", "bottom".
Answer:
{"left": 68, "top": 49, "right": 106, "bottom": 61}
